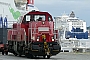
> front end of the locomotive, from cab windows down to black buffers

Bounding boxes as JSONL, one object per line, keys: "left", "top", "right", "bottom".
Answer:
{"left": 25, "top": 12, "right": 61, "bottom": 56}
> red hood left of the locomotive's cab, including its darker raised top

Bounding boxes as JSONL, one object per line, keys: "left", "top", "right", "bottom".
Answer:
{"left": 7, "top": 23, "right": 26, "bottom": 41}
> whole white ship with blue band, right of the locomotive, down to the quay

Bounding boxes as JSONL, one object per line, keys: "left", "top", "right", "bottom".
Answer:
{"left": 55, "top": 11, "right": 90, "bottom": 52}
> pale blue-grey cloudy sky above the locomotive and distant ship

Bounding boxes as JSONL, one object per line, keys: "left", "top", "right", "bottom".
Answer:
{"left": 34, "top": 0, "right": 90, "bottom": 26}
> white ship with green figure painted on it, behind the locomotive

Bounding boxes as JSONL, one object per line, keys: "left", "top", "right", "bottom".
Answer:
{"left": 0, "top": 0, "right": 39, "bottom": 28}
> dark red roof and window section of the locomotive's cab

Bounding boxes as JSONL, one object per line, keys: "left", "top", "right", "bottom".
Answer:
{"left": 22, "top": 11, "right": 53, "bottom": 23}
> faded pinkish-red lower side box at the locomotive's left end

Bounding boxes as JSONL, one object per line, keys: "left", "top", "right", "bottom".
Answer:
{"left": 7, "top": 28, "right": 25, "bottom": 41}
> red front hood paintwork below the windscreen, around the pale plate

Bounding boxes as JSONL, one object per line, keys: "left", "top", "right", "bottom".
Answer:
{"left": 29, "top": 21, "right": 54, "bottom": 42}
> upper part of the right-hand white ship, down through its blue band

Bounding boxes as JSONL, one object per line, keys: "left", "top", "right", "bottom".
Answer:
{"left": 56, "top": 11, "right": 88, "bottom": 39}
